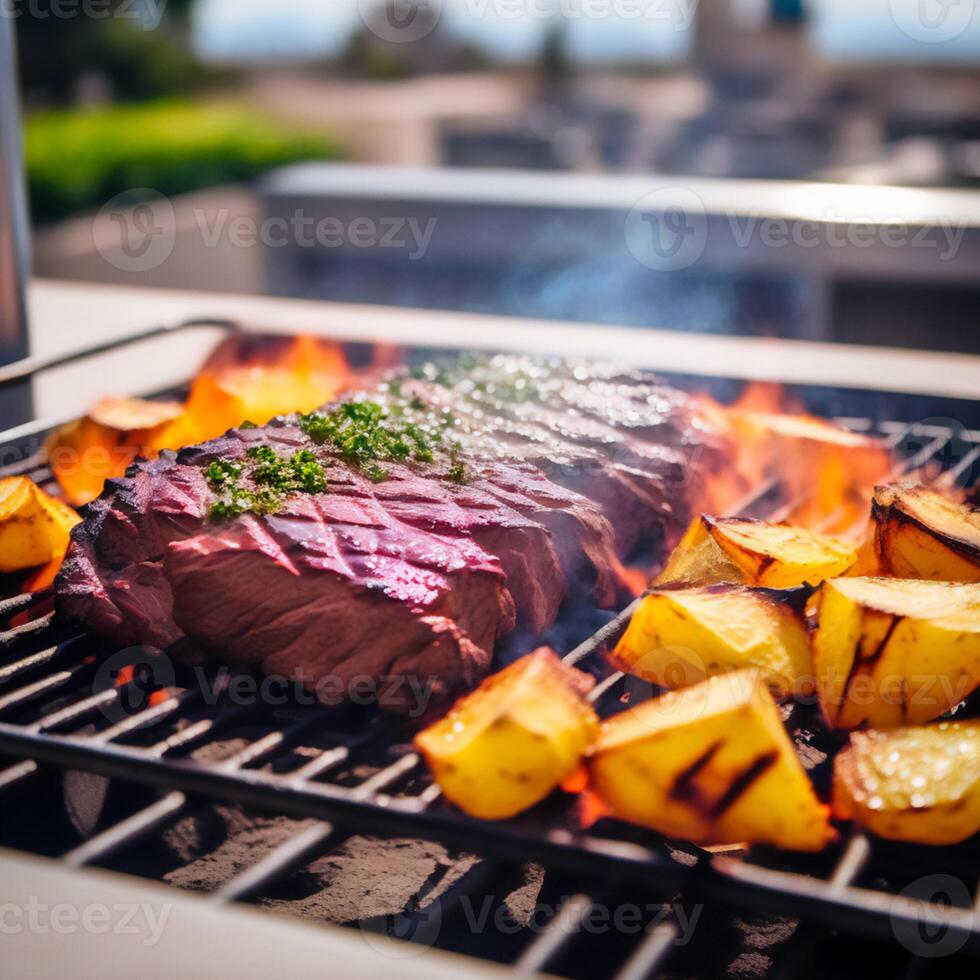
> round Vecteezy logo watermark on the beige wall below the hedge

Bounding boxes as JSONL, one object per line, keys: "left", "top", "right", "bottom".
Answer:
{"left": 92, "top": 187, "right": 177, "bottom": 272}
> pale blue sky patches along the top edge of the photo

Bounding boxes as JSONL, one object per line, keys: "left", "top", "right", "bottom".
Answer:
{"left": 195, "top": 0, "right": 980, "bottom": 62}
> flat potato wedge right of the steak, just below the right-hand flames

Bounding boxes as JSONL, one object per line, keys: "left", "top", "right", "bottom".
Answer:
{"left": 657, "top": 514, "right": 857, "bottom": 589}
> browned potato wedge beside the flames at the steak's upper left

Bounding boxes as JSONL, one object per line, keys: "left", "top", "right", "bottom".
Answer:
{"left": 47, "top": 398, "right": 183, "bottom": 506}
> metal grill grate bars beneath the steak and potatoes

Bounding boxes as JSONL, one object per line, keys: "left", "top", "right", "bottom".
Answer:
{"left": 0, "top": 334, "right": 980, "bottom": 980}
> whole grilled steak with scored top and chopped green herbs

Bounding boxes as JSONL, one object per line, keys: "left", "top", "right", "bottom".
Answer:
{"left": 56, "top": 358, "right": 721, "bottom": 700}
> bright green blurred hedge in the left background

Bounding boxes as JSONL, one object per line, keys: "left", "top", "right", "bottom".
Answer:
{"left": 25, "top": 102, "right": 340, "bottom": 222}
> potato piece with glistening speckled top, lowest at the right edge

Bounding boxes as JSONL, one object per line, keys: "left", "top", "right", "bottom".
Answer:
{"left": 833, "top": 721, "right": 980, "bottom": 845}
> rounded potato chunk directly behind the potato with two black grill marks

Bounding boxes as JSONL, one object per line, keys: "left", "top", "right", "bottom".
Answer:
{"left": 612, "top": 585, "right": 814, "bottom": 695}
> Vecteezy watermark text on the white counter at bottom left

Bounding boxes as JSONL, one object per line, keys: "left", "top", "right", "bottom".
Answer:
{"left": 0, "top": 895, "right": 173, "bottom": 949}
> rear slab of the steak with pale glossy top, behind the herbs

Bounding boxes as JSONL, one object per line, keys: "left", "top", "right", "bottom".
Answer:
{"left": 371, "top": 355, "right": 731, "bottom": 562}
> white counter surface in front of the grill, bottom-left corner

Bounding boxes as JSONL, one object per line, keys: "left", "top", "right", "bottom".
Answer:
{"left": 0, "top": 849, "right": 509, "bottom": 980}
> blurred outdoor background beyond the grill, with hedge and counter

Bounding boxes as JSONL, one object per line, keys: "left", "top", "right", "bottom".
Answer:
{"left": 13, "top": 0, "right": 980, "bottom": 351}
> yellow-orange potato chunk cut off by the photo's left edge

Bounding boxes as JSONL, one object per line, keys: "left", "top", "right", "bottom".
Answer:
{"left": 0, "top": 476, "right": 80, "bottom": 572}
